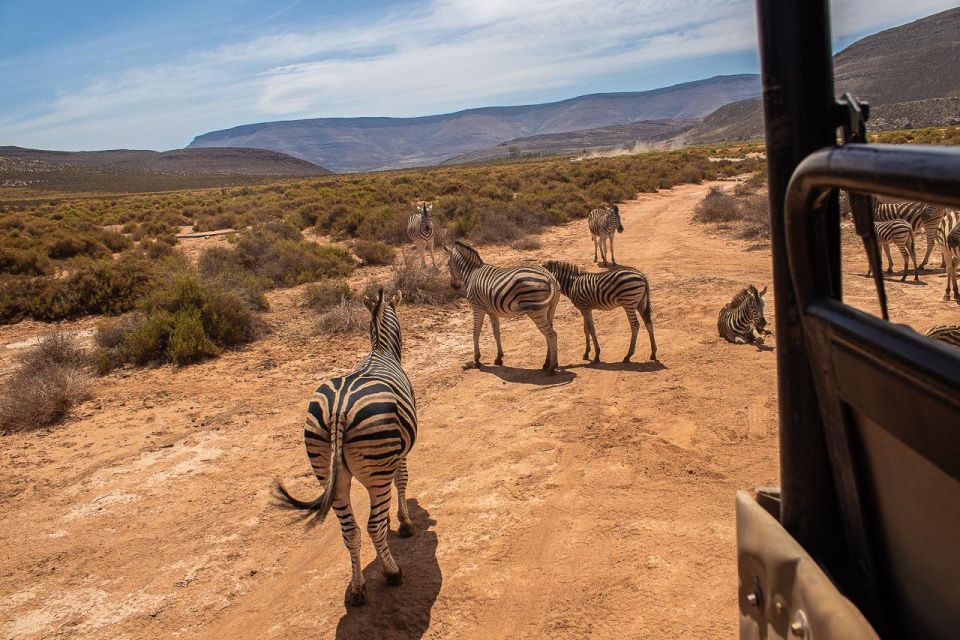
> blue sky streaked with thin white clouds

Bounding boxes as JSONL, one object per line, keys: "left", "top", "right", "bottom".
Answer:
{"left": 0, "top": 0, "right": 955, "bottom": 150}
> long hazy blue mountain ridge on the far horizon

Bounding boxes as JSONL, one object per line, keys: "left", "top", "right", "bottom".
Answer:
{"left": 188, "top": 75, "right": 760, "bottom": 172}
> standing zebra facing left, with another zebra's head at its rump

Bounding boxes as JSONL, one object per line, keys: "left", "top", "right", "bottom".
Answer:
{"left": 443, "top": 240, "right": 559, "bottom": 375}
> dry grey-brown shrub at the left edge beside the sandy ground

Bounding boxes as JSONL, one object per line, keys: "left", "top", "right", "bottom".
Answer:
{"left": 0, "top": 332, "right": 91, "bottom": 432}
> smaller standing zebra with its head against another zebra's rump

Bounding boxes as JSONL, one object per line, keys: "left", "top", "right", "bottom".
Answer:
{"left": 543, "top": 260, "right": 657, "bottom": 362}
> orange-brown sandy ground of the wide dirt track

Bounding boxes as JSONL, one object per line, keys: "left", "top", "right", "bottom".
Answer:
{"left": 0, "top": 185, "right": 960, "bottom": 639}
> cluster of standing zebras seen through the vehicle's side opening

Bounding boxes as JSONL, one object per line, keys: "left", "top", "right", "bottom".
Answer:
{"left": 840, "top": 191, "right": 960, "bottom": 303}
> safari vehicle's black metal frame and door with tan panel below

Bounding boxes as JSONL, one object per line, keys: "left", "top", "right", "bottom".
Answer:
{"left": 737, "top": 0, "right": 960, "bottom": 638}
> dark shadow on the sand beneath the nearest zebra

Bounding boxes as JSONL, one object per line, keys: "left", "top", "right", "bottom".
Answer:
{"left": 336, "top": 499, "right": 443, "bottom": 640}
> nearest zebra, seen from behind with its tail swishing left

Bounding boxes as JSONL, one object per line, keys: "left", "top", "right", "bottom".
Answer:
{"left": 275, "top": 289, "right": 417, "bottom": 606}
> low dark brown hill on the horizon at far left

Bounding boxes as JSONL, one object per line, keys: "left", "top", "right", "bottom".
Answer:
{"left": 0, "top": 147, "right": 331, "bottom": 192}
